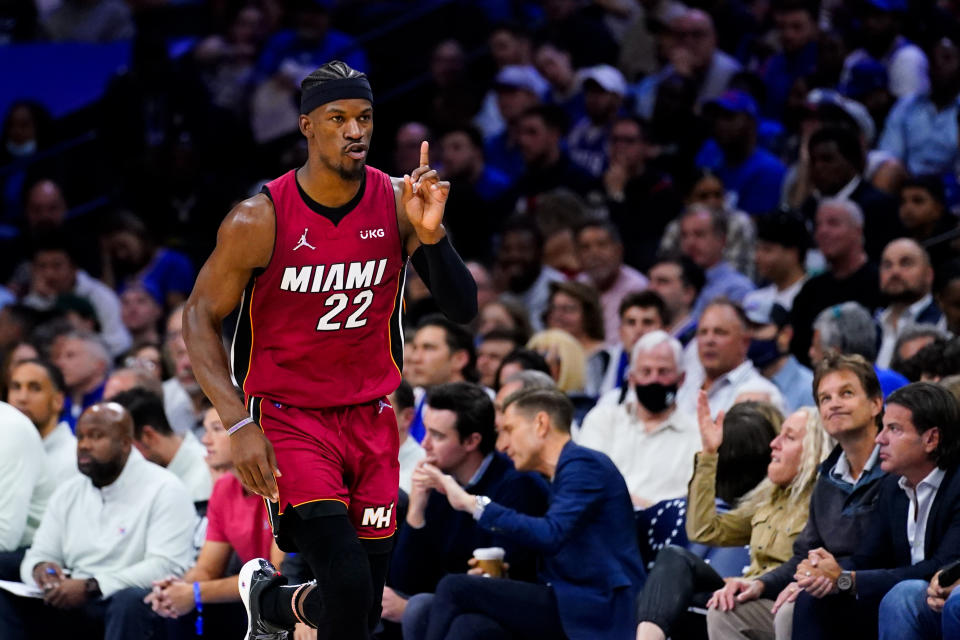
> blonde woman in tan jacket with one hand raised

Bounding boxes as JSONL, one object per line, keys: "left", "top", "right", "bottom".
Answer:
{"left": 637, "top": 392, "right": 833, "bottom": 640}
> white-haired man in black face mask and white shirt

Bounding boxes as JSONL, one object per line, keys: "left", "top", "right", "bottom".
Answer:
{"left": 577, "top": 329, "right": 700, "bottom": 507}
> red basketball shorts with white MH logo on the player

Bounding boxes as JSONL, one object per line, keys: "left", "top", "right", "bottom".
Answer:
{"left": 249, "top": 397, "right": 400, "bottom": 551}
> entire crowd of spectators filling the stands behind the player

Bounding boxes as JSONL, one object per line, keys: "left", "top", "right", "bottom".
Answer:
{"left": 0, "top": 0, "right": 960, "bottom": 640}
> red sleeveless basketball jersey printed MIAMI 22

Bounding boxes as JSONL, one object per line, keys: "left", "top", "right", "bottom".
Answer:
{"left": 237, "top": 167, "right": 405, "bottom": 409}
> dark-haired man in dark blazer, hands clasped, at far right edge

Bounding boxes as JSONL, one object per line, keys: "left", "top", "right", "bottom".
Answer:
{"left": 793, "top": 382, "right": 960, "bottom": 640}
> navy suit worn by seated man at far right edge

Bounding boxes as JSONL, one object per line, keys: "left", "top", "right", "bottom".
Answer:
{"left": 793, "top": 467, "right": 960, "bottom": 640}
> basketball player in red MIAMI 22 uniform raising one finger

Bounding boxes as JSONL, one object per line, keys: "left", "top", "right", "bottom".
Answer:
{"left": 183, "top": 61, "right": 477, "bottom": 640}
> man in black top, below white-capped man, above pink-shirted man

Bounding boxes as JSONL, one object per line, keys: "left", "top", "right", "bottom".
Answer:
{"left": 603, "top": 117, "right": 681, "bottom": 270}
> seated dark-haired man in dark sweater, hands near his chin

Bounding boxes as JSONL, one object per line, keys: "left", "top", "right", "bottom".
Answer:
{"left": 383, "top": 382, "right": 547, "bottom": 637}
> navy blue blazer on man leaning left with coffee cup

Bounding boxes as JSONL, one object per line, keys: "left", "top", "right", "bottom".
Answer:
{"left": 472, "top": 441, "right": 646, "bottom": 640}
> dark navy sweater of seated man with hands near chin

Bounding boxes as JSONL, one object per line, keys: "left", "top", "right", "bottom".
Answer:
{"left": 387, "top": 453, "right": 548, "bottom": 595}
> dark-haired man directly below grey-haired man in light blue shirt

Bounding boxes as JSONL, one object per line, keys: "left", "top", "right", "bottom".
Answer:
{"left": 649, "top": 256, "right": 706, "bottom": 347}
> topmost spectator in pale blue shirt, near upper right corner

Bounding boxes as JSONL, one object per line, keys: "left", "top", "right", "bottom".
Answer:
{"left": 840, "top": 0, "right": 927, "bottom": 98}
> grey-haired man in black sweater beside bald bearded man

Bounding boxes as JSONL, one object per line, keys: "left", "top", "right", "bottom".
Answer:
{"left": 790, "top": 198, "right": 881, "bottom": 364}
